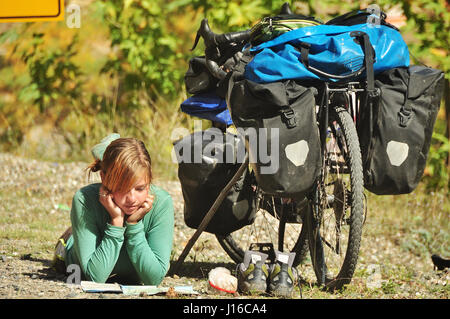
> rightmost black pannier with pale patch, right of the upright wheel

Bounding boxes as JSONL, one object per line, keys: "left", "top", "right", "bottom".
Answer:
{"left": 358, "top": 66, "right": 444, "bottom": 195}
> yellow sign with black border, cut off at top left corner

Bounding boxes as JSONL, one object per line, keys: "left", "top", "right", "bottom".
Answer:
{"left": 0, "top": 0, "right": 64, "bottom": 22}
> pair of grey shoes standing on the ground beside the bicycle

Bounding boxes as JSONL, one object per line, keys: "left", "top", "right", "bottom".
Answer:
{"left": 237, "top": 250, "right": 297, "bottom": 297}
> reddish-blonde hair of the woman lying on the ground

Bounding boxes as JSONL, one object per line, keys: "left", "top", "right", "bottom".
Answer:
{"left": 87, "top": 138, "right": 152, "bottom": 192}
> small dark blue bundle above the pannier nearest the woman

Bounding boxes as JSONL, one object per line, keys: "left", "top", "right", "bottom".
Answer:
{"left": 181, "top": 92, "right": 233, "bottom": 125}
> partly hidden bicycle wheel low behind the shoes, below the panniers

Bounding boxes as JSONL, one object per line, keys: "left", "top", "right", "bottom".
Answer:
{"left": 216, "top": 199, "right": 311, "bottom": 267}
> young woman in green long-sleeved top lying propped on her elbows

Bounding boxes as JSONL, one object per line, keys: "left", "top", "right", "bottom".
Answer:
{"left": 51, "top": 134, "right": 174, "bottom": 285}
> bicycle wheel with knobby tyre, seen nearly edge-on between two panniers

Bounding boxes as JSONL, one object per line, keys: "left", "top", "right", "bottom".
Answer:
{"left": 306, "top": 108, "right": 364, "bottom": 290}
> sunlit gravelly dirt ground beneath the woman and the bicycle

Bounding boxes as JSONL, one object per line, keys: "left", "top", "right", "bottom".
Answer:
{"left": 0, "top": 153, "right": 450, "bottom": 299}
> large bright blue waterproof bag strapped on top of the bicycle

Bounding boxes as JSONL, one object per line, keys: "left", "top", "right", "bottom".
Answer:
{"left": 244, "top": 23, "right": 409, "bottom": 83}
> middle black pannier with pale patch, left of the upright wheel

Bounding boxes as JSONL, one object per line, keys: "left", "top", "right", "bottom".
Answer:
{"left": 226, "top": 52, "right": 321, "bottom": 198}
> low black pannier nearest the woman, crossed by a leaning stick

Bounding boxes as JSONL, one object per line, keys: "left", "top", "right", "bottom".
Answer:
{"left": 174, "top": 128, "right": 256, "bottom": 235}
